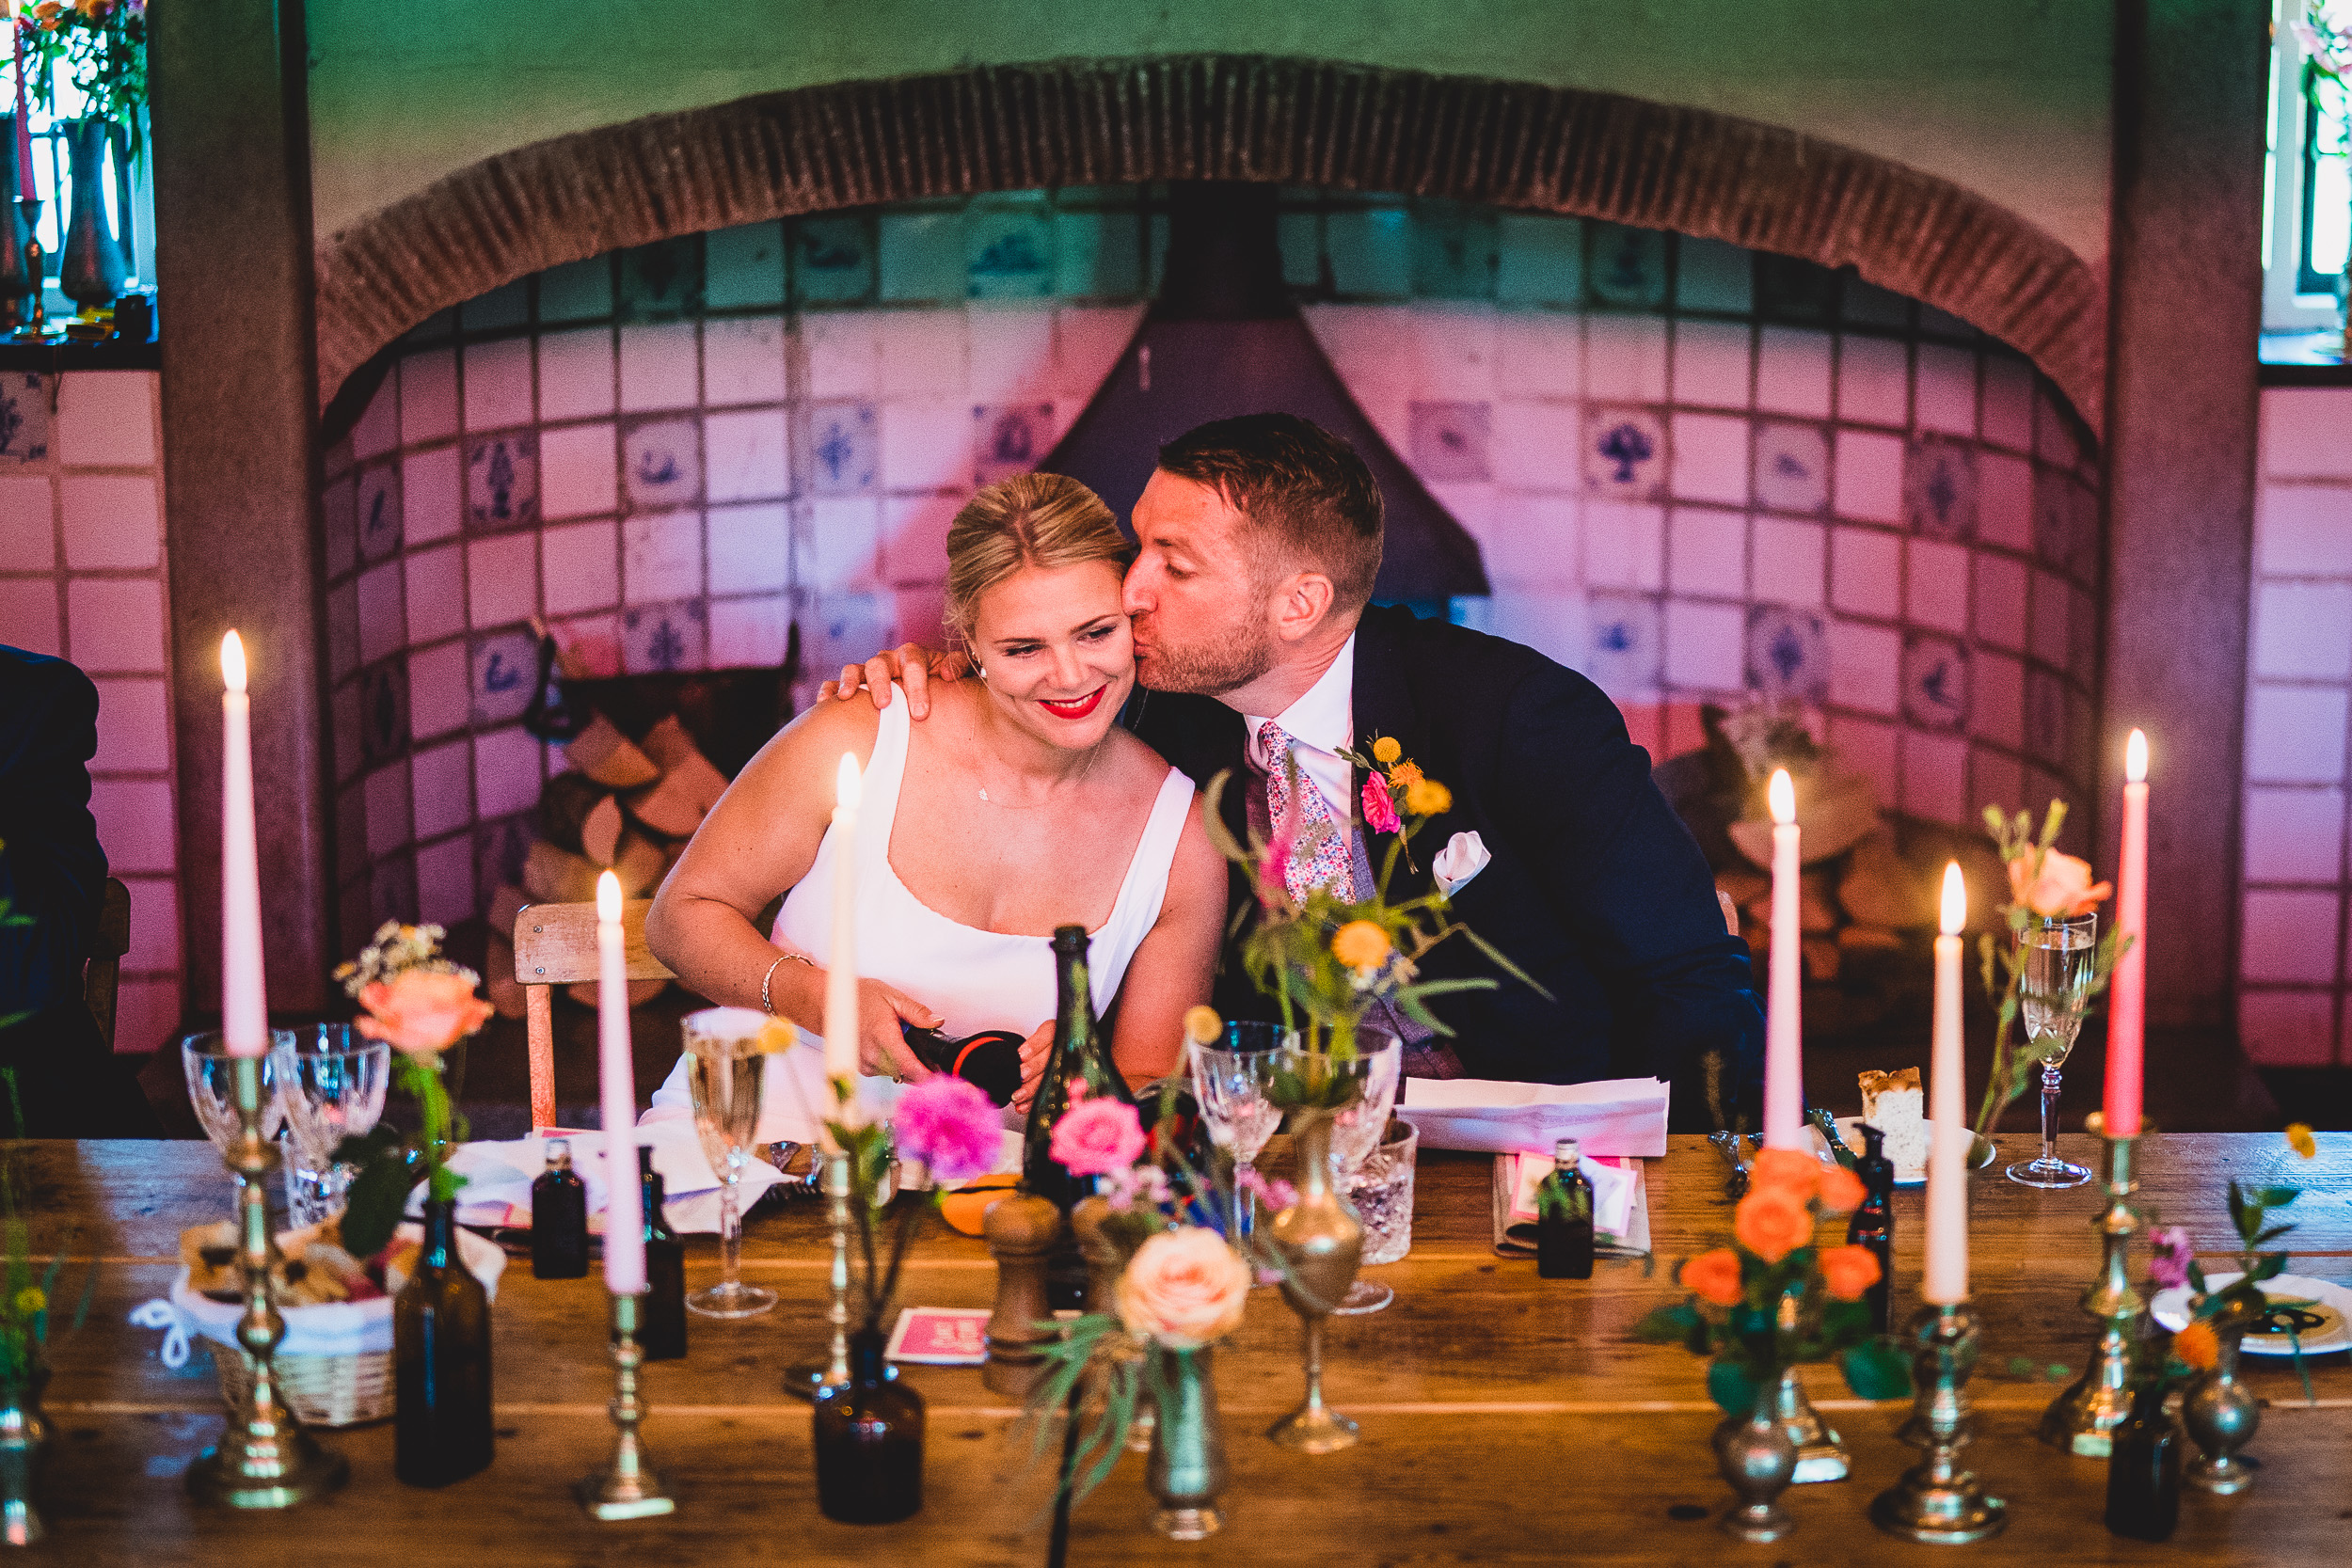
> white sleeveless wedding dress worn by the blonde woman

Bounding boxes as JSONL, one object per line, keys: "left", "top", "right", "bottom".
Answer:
{"left": 643, "top": 687, "right": 1193, "bottom": 1143}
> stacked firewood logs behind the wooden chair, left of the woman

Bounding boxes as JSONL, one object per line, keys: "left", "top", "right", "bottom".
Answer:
{"left": 487, "top": 715, "right": 727, "bottom": 1018}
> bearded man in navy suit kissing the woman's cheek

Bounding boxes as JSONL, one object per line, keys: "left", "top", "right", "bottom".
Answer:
{"left": 842, "top": 414, "right": 1764, "bottom": 1131}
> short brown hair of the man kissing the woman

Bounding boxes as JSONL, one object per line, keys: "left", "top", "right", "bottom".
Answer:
{"left": 1160, "top": 414, "right": 1381, "bottom": 613}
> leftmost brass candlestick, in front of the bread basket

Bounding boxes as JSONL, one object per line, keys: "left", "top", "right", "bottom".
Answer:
{"left": 188, "top": 1055, "right": 351, "bottom": 1510}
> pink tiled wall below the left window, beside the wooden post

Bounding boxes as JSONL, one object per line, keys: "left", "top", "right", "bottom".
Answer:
{"left": 0, "top": 372, "right": 182, "bottom": 1051}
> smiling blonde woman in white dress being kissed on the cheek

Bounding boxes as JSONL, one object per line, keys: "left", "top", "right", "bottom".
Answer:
{"left": 644, "top": 472, "right": 1226, "bottom": 1140}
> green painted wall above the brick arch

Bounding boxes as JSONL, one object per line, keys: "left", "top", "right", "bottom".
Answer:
{"left": 309, "top": 0, "right": 2112, "bottom": 261}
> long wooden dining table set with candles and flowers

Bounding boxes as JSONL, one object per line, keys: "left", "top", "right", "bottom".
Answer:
{"left": 8, "top": 1133, "right": 2352, "bottom": 1568}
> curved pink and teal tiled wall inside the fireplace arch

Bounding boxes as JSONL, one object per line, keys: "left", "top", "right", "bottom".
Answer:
{"left": 327, "top": 190, "right": 2101, "bottom": 945}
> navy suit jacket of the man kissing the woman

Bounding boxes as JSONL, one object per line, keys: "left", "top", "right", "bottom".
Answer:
{"left": 1129, "top": 607, "right": 1764, "bottom": 1129}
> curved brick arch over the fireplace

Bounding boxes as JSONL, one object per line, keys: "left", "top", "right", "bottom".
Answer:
{"left": 318, "top": 54, "right": 2106, "bottom": 433}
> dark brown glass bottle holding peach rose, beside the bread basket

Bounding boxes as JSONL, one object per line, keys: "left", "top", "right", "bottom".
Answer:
{"left": 393, "top": 1201, "right": 497, "bottom": 1486}
